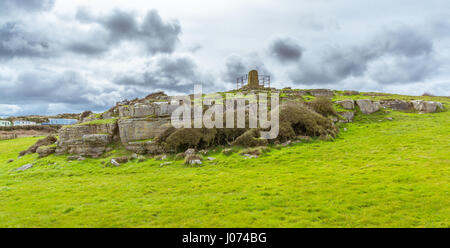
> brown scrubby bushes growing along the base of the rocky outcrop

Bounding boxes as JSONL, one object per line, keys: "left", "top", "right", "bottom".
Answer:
{"left": 155, "top": 98, "right": 338, "bottom": 152}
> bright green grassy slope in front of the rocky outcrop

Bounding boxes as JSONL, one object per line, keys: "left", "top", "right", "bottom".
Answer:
{"left": 0, "top": 97, "right": 450, "bottom": 227}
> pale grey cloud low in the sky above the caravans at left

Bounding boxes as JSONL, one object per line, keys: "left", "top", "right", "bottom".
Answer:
{"left": 0, "top": 70, "right": 127, "bottom": 115}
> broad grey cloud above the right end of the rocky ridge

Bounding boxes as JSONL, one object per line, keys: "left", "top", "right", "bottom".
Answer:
{"left": 289, "top": 26, "right": 437, "bottom": 85}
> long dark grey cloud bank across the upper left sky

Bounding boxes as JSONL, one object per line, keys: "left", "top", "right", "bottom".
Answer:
{"left": 0, "top": 9, "right": 181, "bottom": 60}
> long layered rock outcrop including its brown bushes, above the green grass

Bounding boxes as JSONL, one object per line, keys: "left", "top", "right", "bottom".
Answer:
{"left": 21, "top": 89, "right": 443, "bottom": 161}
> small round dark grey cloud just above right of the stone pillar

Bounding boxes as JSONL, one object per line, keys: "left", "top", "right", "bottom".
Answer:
{"left": 269, "top": 38, "right": 302, "bottom": 63}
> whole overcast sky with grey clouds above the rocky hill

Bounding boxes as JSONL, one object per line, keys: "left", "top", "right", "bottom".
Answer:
{"left": 0, "top": 0, "right": 450, "bottom": 116}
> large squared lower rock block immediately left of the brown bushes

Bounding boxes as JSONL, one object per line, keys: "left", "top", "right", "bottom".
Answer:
{"left": 119, "top": 117, "right": 171, "bottom": 143}
